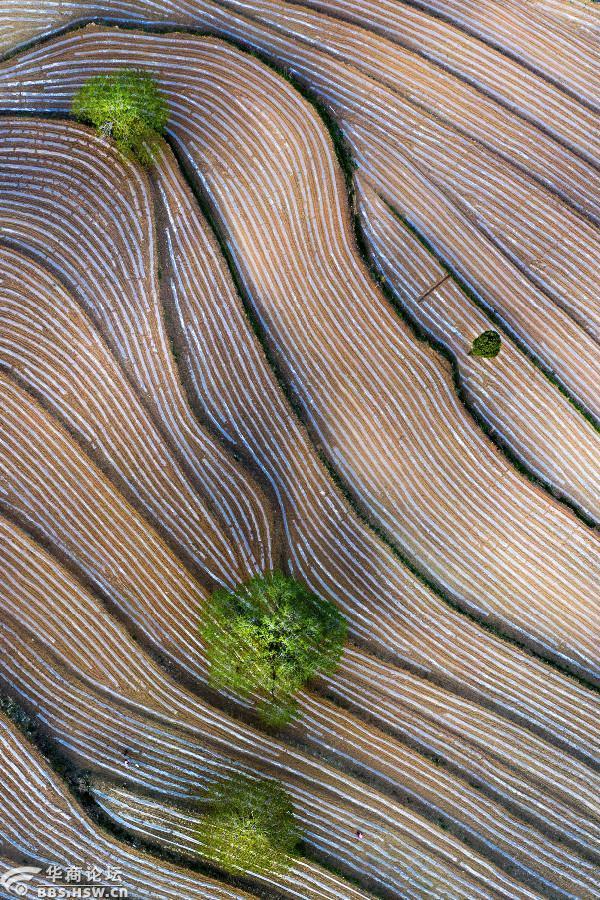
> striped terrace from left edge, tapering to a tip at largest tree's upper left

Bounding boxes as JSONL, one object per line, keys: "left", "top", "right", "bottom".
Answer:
{"left": 0, "top": 246, "right": 247, "bottom": 586}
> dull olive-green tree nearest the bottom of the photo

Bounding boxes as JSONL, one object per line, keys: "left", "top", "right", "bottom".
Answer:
{"left": 197, "top": 774, "right": 300, "bottom": 874}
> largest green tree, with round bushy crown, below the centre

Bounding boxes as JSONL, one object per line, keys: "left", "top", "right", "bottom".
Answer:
{"left": 200, "top": 572, "right": 346, "bottom": 727}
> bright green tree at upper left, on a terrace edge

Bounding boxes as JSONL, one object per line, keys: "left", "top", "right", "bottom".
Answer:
{"left": 71, "top": 69, "right": 169, "bottom": 165}
